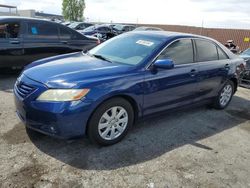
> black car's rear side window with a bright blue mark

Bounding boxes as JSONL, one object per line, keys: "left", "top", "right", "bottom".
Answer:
{"left": 28, "top": 23, "right": 58, "bottom": 39}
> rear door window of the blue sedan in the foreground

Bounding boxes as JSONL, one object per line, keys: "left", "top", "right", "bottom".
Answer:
{"left": 195, "top": 40, "right": 218, "bottom": 62}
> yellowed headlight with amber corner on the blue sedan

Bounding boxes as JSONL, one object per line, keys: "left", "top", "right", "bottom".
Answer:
{"left": 37, "top": 89, "right": 90, "bottom": 101}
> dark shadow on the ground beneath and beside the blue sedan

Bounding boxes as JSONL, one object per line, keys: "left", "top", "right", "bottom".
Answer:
{"left": 28, "top": 96, "right": 250, "bottom": 170}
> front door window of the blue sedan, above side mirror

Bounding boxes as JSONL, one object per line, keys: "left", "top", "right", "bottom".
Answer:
{"left": 158, "top": 39, "right": 194, "bottom": 65}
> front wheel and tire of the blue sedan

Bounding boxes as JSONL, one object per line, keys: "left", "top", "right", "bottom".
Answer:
{"left": 87, "top": 98, "right": 134, "bottom": 146}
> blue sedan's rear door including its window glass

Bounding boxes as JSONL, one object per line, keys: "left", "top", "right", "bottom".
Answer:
{"left": 194, "top": 39, "right": 230, "bottom": 100}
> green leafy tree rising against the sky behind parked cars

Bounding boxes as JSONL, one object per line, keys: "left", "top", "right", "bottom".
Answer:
{"left": 62, "top": 0, "right": 85, "bottom": 21}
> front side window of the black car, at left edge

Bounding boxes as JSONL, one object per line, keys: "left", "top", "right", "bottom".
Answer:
{"left": 0, "top": 22, "right": 20, "bottom": 39}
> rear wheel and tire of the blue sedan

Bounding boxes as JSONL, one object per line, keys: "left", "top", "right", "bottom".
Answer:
{"left": 213, "top": 80, "right": 235, "bottom": 110}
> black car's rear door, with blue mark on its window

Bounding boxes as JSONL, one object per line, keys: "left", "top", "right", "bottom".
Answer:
{"left": 24, "top": 21, "right": 62, "bottom": 64}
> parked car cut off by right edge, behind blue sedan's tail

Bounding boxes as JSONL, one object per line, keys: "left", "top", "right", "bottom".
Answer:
{"left": 240, "top": 48, "right": 250, "bottom": 88}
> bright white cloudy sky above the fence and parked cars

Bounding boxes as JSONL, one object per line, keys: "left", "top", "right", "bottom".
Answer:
{"left": 0, "top": 0, "right": 250, "bottom": 29}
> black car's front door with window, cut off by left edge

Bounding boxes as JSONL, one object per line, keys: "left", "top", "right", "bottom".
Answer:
{"left": 0, "top": 21, "right": 24, "bottom": 68}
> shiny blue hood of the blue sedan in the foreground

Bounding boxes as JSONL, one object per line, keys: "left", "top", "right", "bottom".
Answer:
{"left": 23, "top": 52, "right": 133, "bottom": 88}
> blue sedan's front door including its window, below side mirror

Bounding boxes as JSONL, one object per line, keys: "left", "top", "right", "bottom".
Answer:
{"left": 144, "top": 39, "right": 199, "bottom": 115}
